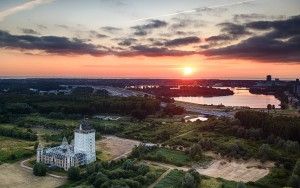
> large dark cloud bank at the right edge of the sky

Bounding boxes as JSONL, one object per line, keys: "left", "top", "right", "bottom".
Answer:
{"left": 204, "top": 16, "right": 300, "bottom": 62}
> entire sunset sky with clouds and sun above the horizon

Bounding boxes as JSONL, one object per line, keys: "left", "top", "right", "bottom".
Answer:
{"left": 0, "top": 0, "right": 300, "bottom": 79}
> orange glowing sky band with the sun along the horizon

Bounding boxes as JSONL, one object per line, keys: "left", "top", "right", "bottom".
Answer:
{"left": 0, "top": 50, "right": 300, "bottom": 79}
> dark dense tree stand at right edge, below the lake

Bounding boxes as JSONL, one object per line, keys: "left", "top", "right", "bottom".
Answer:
{"left": 235, "top": 110, "right": 300, "bottom": 142}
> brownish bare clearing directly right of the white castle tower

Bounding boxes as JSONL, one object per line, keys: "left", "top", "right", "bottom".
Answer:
{"left": 96, "top": 136, "right": 141, "bottom": 160}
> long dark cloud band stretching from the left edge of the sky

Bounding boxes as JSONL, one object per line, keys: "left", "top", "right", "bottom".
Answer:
{"left": 0, "top": 30, "right": 194, "bottom": 57}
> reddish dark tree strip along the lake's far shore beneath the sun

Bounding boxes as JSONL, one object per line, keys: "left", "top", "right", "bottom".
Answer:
{"left": 135, "top": 86, "right": 234, "bottom": 97}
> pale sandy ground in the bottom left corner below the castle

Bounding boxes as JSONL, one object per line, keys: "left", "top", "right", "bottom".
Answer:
{"left": 0, "top": 162, "right": 65, "bottom": 188}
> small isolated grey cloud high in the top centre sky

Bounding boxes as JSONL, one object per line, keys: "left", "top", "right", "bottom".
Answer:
{"left": 131, "top": 20, "right": 168, "bottom": 36}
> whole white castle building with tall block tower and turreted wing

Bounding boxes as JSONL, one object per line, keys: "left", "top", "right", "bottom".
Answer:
{"left": 36, "top": 121, "right": 96, "bottom": 170}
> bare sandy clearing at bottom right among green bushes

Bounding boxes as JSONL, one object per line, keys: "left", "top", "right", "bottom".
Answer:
{"left": 197, "top": 159, "right": 274, "bottom": 182}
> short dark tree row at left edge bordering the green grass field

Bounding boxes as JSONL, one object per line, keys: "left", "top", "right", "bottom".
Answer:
{"left": 0, "top": 126, "right": 37, "bottom": 141}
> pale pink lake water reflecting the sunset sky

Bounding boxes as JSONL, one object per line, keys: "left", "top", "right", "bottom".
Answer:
{"left": 174, "top": 87, "right": 280, "bottom": 108}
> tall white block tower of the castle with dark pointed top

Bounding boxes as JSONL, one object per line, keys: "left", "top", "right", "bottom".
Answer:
{"left": 74, "top": 120, "right": 96, "bottom": 163}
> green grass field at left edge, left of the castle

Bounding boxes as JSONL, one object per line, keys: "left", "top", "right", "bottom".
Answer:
{"left": 0, "top": 136, "right": 35, "bottom": 162}
